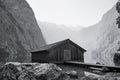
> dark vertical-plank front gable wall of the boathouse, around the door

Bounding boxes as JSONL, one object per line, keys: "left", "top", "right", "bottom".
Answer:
{"left": 49, "top": 42, "right": 84, "bottom": 62}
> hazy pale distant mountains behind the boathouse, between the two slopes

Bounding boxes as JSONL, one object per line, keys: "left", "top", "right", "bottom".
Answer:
{"left": 38, "top": 21, "right": 83, "bottom": 44}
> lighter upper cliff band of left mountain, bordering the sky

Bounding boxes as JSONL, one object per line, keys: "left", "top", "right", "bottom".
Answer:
{"left": 1, "top": 0, "right": 45, "bottom": 51}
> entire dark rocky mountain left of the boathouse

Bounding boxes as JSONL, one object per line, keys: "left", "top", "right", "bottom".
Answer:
{"left": 0, "top": 0, "right": 45, "bottom": 63}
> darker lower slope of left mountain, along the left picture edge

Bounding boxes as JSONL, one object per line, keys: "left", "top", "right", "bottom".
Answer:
{"left": 0, "top": 6, "right": 30, "bottom": 62}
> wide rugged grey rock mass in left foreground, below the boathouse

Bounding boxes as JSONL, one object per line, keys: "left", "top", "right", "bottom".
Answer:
{"left": 0, "top": 62, "right": 65, "bottom": 80}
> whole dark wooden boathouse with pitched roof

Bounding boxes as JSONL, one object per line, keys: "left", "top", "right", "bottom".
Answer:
{"left": 31, "top": 39, "right": 86, "bottom": 63}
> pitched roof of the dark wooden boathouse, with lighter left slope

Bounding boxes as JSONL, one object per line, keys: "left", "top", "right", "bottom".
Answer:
{"left": 32, "top": 39, "right": 86, "bottom": 52}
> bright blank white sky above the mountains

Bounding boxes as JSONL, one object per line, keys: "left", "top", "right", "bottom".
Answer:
{"left": 27, "top": 0, "right": 118, "bottom": 26}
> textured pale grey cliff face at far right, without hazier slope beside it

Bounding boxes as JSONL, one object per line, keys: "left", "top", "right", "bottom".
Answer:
{"left": 91, "top": 6, "right": 120, "bottom": 65}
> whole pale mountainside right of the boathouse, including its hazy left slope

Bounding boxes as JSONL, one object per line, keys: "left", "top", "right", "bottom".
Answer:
{"left": 71, "top": 6, "right": 120, "bottom": 65}
